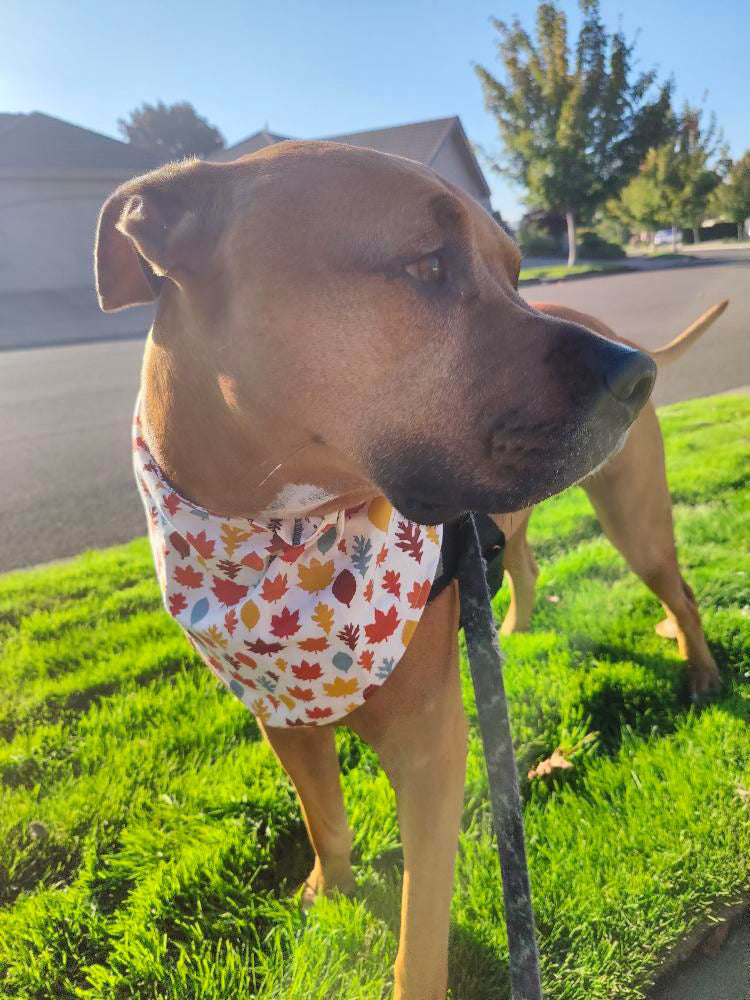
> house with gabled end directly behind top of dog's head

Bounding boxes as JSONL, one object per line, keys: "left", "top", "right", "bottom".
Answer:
{"left": 210, "top": 116, "right": 492, "bottom": 212}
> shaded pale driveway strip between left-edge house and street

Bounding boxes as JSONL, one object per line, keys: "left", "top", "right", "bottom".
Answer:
{"left": 0, "top": 287, "right": 154, "bottom": 351}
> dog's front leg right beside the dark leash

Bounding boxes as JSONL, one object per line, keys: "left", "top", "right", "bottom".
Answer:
{"left": 347, "top": 587, "right": 467, "bottom": 1000}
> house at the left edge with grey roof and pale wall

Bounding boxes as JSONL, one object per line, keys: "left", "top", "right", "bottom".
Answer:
{"left": 0, "top": 111, "right": 158, "bottom": 293}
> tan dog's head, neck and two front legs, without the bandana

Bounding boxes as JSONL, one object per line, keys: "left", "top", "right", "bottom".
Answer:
{"left": 96, "top": 142, "right": 655, "bottom": 1000}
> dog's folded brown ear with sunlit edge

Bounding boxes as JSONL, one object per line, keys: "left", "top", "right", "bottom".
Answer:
{"left": 94, "top": 160, "right": 221, "bottom": 312}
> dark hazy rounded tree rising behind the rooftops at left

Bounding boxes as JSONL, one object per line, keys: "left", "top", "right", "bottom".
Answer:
{"left": 117, "top": 101, "right": 224, "bottom": 160}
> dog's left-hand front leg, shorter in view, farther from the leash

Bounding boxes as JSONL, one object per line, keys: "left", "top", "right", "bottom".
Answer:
{"left": 261, "top": 726, "right": 354, "bottom": 906}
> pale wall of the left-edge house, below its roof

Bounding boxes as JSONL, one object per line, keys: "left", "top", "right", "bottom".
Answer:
{"left": 0, "top": 175, "right": 126, "bottom": 292}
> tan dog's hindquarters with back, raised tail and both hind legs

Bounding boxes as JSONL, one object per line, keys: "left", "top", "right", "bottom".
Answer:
{"left": 496, "top": 301, "right": 729, "bottom": 698}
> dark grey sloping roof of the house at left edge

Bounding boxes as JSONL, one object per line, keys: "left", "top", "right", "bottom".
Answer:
{"left": 0, "top": 111, "right": 162, "bottom": 173}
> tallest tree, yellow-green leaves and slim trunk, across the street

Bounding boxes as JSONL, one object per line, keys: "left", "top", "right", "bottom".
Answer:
{"left": 475, "top": 0, "right": 671, "bottom": 266}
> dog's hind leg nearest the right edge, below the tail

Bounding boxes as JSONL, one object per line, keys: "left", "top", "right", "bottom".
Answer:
{"left": 581, "top": 404, "right": 719, "bottom": 695}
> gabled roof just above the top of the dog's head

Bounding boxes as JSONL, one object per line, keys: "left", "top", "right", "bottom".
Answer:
{"left": 211, "top": 115, "right": 490, "bottom": 197}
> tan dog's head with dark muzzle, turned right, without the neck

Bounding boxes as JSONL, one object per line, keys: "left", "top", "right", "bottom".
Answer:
{"left": 96, "top": 142, "right": 655, "bottom": 523}
